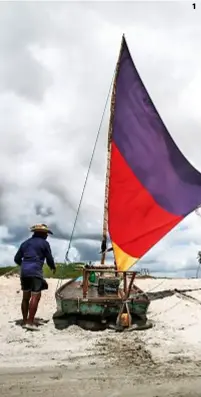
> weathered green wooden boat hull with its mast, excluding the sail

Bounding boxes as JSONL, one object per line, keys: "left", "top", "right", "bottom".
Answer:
{"left": 54, "top": 37, "right": 150, "bottom": 329}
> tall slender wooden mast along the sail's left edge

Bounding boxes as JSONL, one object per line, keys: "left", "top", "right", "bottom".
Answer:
{"left": 101, "top": 34, "right": 124, "bottom": 265}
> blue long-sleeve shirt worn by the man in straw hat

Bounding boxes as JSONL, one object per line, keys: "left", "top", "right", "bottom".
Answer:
{"left": 14, "top": 236, "right": 55, "bottom": 278}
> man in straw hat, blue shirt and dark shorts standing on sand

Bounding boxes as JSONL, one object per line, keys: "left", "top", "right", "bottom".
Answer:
{"left": 14, "top": 224, "right": 56, "bottom": 330}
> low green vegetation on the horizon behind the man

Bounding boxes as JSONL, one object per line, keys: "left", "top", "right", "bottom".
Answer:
{"left": 0, "top": 263, "right": 84, "bottom": 279}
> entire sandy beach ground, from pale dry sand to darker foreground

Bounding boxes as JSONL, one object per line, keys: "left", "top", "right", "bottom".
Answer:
{"left": 0, "top": 277, "right": 201, "bottom": 397}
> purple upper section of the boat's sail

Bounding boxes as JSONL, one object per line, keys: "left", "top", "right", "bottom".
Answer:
{"left": 113, "top": 39, "right": 201, "bottom": 216}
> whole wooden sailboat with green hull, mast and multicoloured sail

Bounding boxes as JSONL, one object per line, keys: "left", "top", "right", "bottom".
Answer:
{"left": 54, "top": 36, "right": 201, "bottom": 328}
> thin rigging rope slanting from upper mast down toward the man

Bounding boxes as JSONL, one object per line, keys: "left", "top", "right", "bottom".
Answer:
{"left": 56, "top": 67, "right": 116, "bottom": 290}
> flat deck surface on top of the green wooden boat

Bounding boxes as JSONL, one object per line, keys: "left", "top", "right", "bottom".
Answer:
{"left": 59, "top": 281, "right": 145, "bottom": 301}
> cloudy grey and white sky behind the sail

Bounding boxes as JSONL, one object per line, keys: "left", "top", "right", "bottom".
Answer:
{"left": 0, "top": 1, "right": 201, "bottom": 276}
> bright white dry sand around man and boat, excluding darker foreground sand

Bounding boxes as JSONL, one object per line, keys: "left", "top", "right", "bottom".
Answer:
{"left": 0, "top": 277, "right": 201, "bottom": 368}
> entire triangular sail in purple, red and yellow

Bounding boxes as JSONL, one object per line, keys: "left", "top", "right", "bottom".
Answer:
{"left": 108, "top": 38, "right": 201, "bottom": 270}
